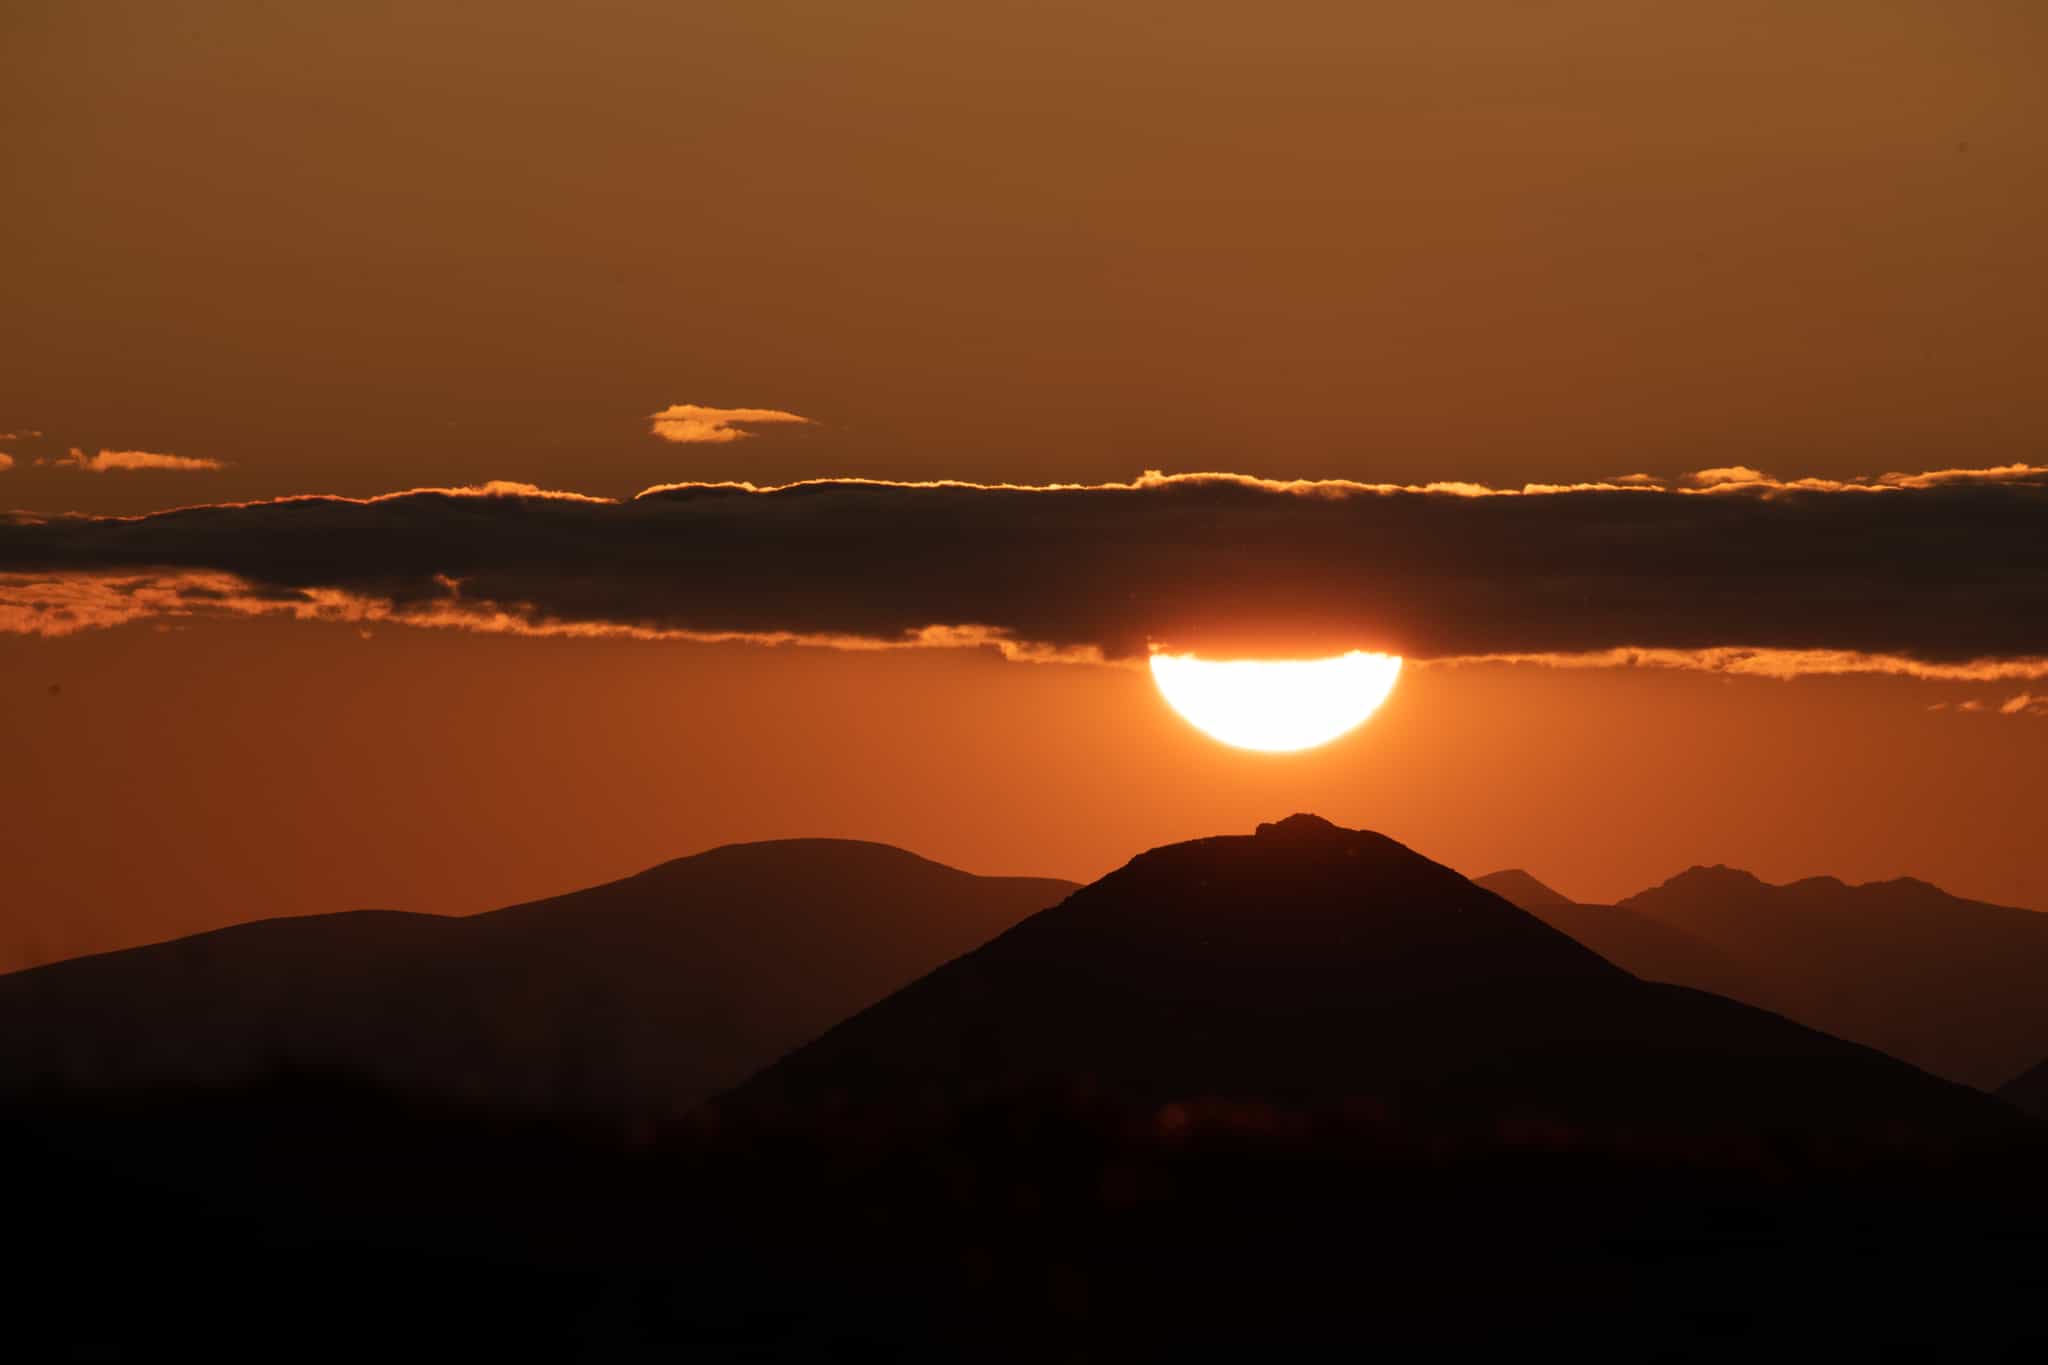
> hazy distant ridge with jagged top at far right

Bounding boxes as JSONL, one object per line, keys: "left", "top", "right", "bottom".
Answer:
{"left": 1616, "top": 868, "right": 2048, "bottom": 1089}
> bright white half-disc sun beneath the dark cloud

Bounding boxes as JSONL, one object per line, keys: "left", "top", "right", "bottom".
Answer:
{"left": 1151, "top": 649, "right": 1401, "bottom": 753}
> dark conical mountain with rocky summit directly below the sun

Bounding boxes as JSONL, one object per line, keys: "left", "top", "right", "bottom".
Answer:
{"left": 727, "top": 817, "right": 2017, "bottom": 1134}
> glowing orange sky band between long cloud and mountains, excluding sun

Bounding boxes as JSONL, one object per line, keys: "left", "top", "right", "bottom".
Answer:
{"left": 0, "top": 622, "right": 2048, "bottom": 966}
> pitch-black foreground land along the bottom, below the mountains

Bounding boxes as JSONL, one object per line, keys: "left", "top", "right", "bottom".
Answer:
{"left": 6, "top": 1078, "right": 2048, "bottom": 1361}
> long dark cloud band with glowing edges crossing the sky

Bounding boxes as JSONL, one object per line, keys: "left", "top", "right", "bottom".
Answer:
{"left": 0, "top": 469, "right": 2048, "bottom": 681}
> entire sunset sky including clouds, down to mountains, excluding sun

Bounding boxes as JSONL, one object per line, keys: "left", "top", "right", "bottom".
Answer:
{"left": 0, "top": 0, "right": 2048, "bottom": 970}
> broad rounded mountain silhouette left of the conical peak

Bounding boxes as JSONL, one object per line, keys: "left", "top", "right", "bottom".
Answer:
{"left": 0, "top": 839, "right": 1073, "bottom": 1111}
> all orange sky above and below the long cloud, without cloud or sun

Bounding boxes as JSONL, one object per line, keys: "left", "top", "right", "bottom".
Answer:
{"left": 0, "top": 0, "right": 2048, "bottom": 968}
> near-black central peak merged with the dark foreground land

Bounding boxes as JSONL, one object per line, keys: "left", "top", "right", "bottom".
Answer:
{"left": 0, "top": 817, "right": 2048, "bottom": 1361}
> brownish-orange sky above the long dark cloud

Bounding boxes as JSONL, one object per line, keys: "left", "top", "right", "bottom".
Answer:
{"left": 0, "top": 0, "right": 2048, "bottom": 512}
